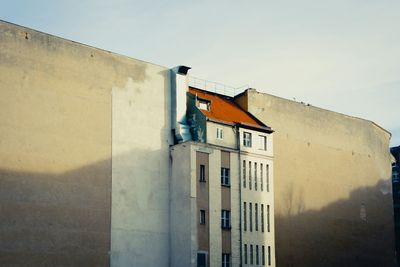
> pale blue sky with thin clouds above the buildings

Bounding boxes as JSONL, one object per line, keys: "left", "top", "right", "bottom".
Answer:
{"left": 0, "top": 0, "right": 400, "bottom": 146}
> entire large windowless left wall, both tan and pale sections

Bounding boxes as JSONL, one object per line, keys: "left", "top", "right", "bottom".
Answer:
{"left": 0, "top": 21, "right": 170, "bottom": 266}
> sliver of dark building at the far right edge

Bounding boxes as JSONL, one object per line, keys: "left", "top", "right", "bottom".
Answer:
{"left": 390, "top": 146, "right": 400, "bottom": 262}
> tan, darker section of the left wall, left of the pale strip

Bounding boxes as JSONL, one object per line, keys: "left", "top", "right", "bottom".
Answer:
{"left": 0, "top": 21, "right": 112, "bottom": 266}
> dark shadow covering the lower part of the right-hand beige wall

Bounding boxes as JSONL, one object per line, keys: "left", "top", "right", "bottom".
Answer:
{"left": 275, "top": 180, "right": 396, "bottom": 267}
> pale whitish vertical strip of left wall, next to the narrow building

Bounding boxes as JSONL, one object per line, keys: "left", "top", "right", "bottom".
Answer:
{"left": 111, "top": 51, "right": 172, "bottom": 267}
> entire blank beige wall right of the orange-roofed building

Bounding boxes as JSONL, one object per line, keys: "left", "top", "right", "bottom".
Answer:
{"left": 238, "top": 90, "right": 394, "bottom": 266}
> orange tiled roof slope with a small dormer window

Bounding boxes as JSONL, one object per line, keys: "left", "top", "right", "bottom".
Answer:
{"left": 189, "top": 87, "right": 268, "bottom": 128}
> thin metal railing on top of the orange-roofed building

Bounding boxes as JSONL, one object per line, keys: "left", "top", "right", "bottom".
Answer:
{"left": 189, "top": 76, "right": 249, "bottom": 97}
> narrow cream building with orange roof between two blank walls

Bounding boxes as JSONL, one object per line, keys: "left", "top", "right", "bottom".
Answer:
{"left": 171, "top": 88, "right": 275, "bottom": 267}
